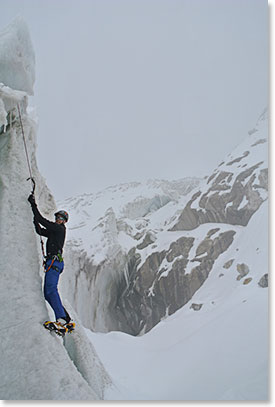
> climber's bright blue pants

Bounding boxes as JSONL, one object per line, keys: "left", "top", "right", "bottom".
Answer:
{"left": 44, "top": 260, "right": 66, "bottom": 319}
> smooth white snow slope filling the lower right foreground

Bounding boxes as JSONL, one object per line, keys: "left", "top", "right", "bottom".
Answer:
{"left": 86, "top": 202, "right": 269, "bottom": 401}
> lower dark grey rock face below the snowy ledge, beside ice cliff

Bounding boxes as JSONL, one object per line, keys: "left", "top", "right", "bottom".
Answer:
{"left": 116, "top": 230, "right": 235, "bottom": 335}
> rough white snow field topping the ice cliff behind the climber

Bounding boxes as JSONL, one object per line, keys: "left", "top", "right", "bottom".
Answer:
{"left": 58, "top": 178, "right": 201, "bottom": 264}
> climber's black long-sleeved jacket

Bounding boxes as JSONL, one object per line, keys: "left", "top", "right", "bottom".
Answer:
{"left": 32, "top": 204, "right": 66, "bottom": 257}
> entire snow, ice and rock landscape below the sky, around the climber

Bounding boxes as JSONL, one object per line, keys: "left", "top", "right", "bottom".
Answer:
{"left": 0, "top": 18, "right": 269, "bottom": 401}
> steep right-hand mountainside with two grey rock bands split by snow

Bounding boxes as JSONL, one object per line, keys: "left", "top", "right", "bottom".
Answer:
{"left": 117, "top": 111, "right": 268, "bottom": 334}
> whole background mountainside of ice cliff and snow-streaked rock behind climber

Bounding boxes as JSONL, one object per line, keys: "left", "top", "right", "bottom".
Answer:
{"left": 60, "top": 110, "right": 268, "bottom": 335}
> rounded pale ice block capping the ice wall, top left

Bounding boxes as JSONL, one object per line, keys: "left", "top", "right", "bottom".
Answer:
{"left": 0, "top": 17, "right": 35, "bottom": 95}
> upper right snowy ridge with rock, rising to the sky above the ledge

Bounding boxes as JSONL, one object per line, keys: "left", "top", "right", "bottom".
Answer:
{"left": 172, "top": 109, "right": 268, "bottom": 230}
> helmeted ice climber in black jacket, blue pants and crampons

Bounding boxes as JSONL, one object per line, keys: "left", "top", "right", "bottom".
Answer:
{"left": 28, "top": 194, "right": 75, "bottom": 336}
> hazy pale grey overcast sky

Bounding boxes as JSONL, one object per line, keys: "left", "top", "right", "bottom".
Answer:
{"left": 0, "top": 0, "right": 269, "bottom": 200}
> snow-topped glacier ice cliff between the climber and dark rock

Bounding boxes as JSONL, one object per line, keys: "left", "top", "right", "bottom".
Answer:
{"left": 59, "top": 178, "right": 200, "bottom": 332}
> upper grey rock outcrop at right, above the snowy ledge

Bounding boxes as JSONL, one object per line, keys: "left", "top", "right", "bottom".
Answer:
{"left": 171, "top": 163, "right": 268, "bottom": 231}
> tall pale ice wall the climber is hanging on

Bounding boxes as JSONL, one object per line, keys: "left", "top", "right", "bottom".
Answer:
{"left": 0, "top": 19, "right": 110, "bottom": 400}
